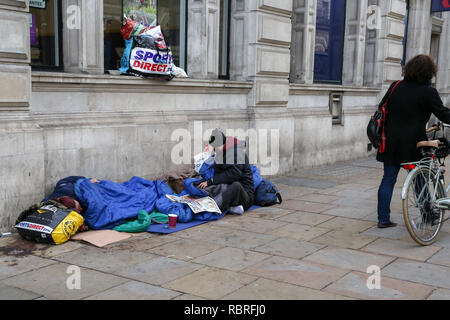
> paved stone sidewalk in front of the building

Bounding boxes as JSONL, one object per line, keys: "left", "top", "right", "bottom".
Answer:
{"left": 0, "top": 157, "right": 450, "bottom": 300}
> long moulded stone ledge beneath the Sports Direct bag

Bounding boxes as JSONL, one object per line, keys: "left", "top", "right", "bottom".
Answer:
{"left": 31, "top": 71, "right": 253, "bottom": 94}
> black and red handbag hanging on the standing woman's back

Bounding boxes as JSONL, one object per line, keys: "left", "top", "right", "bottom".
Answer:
{"left": 367, "top": 81, "right": 401, "bottom": 153}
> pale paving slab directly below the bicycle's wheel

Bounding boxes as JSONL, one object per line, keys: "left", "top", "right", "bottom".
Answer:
{"left": 361, "top": 239, "right": 440, "bottom": 261}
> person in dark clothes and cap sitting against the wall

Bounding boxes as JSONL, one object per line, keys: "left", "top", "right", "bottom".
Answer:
{"left": 199, "top": 129, "right": 255, "bottom": 214}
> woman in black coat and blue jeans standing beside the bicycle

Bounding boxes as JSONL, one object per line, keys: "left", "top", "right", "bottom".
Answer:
{"left": 377, "top": 54, "right": 450, "bottom": 228}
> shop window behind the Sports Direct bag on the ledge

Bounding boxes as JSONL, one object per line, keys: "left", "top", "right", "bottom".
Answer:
{"left": 103, "top": 0, "right": 186, "bottom": 71}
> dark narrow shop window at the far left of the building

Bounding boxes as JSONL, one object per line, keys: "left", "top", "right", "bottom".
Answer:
{"left": 29, "top": 0, "right": 63, "bottom": 69}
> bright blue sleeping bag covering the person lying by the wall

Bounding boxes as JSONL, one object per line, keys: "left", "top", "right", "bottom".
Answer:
{"left": 74, "top": 177, "right": 158, "bottom": 230}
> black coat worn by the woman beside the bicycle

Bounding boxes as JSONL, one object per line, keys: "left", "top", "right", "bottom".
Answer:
{"left": 377, "top": 81, "right": 450, "bottom": 165}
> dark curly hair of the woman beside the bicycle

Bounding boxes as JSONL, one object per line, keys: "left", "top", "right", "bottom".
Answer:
{"left": 405, "top": 54, "right": 437, "bottom": 84}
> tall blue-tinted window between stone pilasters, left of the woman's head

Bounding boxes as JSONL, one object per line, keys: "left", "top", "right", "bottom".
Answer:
{"left": 314, "top": 0, "right": 346, "bottom": 83}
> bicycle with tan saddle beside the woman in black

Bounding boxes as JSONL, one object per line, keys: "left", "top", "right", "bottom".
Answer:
{"left": 401, "top": 122, "right": 450, "bottom": 246}
